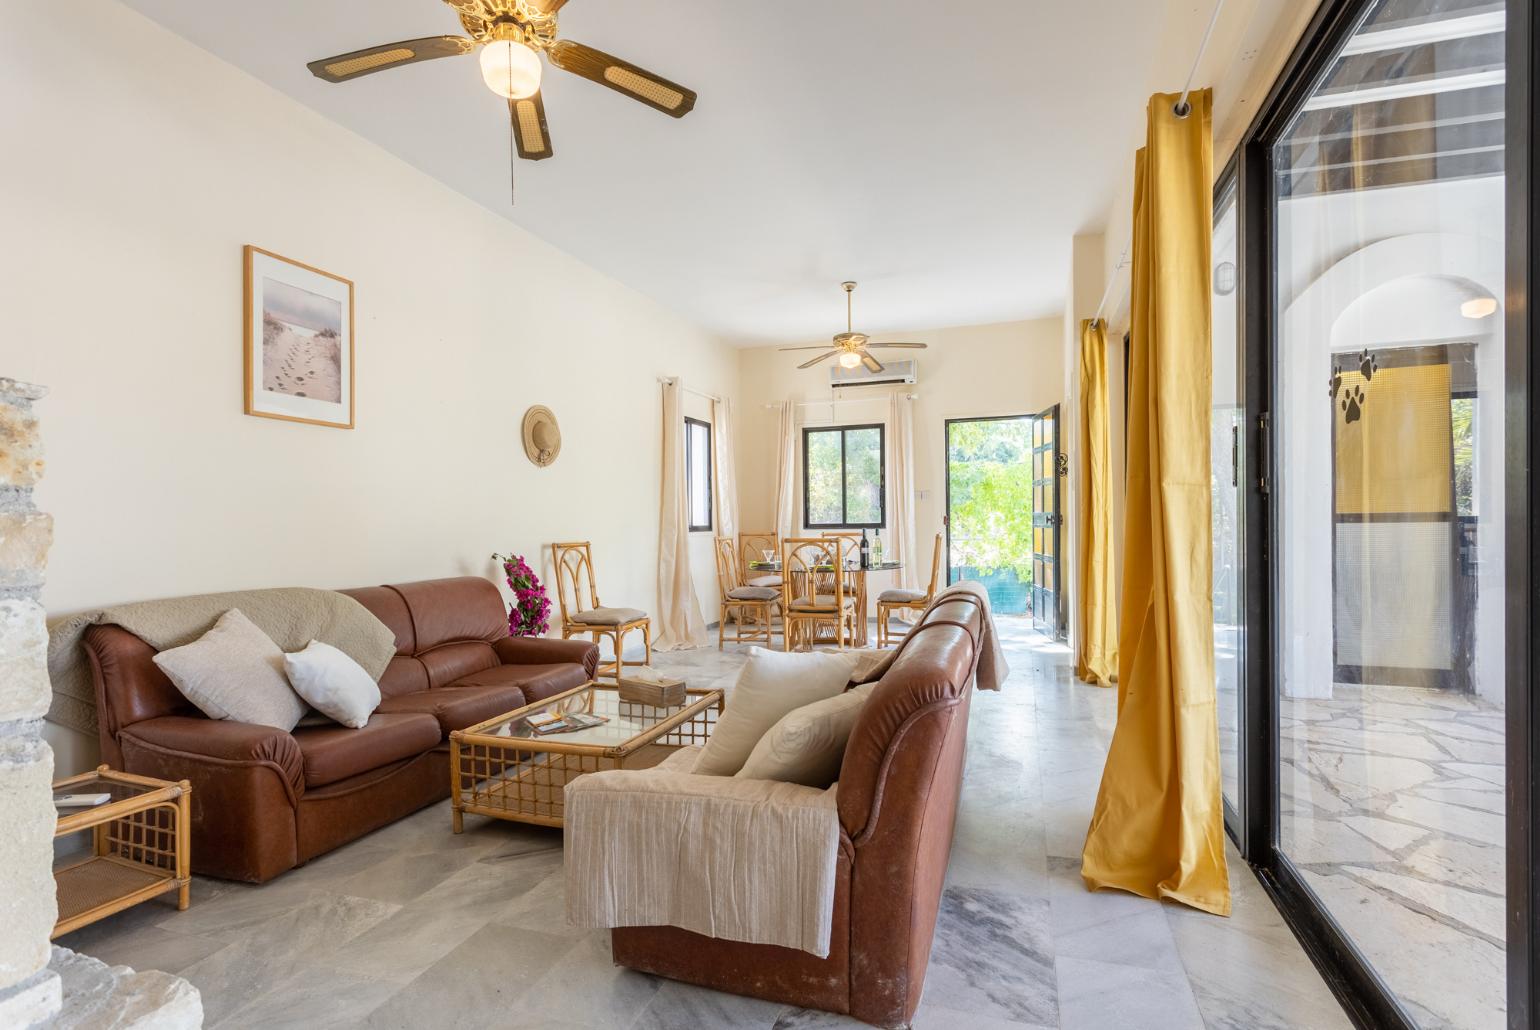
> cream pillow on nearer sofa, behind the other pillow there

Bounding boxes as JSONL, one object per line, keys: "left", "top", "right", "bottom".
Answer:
{"left": 695, "top": 647, "right": 856, "bottom": 776}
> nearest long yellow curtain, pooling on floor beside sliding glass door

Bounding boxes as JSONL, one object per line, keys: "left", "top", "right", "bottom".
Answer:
{"left": 1081, "top": 91, "right": 1230, "bottom": 915}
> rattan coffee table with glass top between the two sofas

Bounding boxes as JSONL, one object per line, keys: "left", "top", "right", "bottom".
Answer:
{"left": 450, "top": 682, "right": 724, "bottom": 833}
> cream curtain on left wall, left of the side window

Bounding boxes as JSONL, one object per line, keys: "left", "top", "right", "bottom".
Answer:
{"left": 653, "top": 379, "right": 705, "bottom": 651}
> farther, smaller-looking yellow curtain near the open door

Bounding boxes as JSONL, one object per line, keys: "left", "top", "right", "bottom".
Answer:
{"left": 1075, "top": 320, "right": 1118, "bottom": 685}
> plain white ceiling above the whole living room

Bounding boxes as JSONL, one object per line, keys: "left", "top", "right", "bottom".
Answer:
{"left": 117, "top": 0, "right": 1201, "bottom": 345}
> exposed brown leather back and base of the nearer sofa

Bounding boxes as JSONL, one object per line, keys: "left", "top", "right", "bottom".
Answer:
{"left": 610, "top": 594, "right": 983, "bottom": 1027}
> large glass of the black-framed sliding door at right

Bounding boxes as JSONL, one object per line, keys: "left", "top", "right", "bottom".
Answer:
{"left": 1244, "top": 0, "right": 1531, "bottom": 1030}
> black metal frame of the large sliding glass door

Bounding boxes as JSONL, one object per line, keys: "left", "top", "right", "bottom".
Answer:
{"left": 1227, "top": 0, "right": 1540, "bottom": 1028}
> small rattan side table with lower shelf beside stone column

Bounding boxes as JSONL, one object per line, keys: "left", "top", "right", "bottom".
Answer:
{"left": 52, "top": 765, "right": 193, "bottom": 938}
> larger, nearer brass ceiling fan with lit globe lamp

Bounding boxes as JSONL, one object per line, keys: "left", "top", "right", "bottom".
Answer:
{"left": 306, "top": 0, "right": 695, "bottom": 172}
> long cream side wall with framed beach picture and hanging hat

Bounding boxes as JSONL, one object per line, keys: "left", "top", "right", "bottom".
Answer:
{"left": 0, "top": 3, "right": 738, "bottom": 773}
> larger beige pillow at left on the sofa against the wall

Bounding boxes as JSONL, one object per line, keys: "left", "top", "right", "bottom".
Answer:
{"left": 156, "top": 608, "right": 305, "bottom": 733}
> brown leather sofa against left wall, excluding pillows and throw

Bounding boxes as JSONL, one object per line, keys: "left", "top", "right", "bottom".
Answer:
{"left": 85, "top": 577, "right": 599, "bottom": 884}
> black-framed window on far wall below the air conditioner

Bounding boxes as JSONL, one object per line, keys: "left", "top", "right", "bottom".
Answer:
{"left": 802, "top": 425, "right": 887, "bottom": 530}
